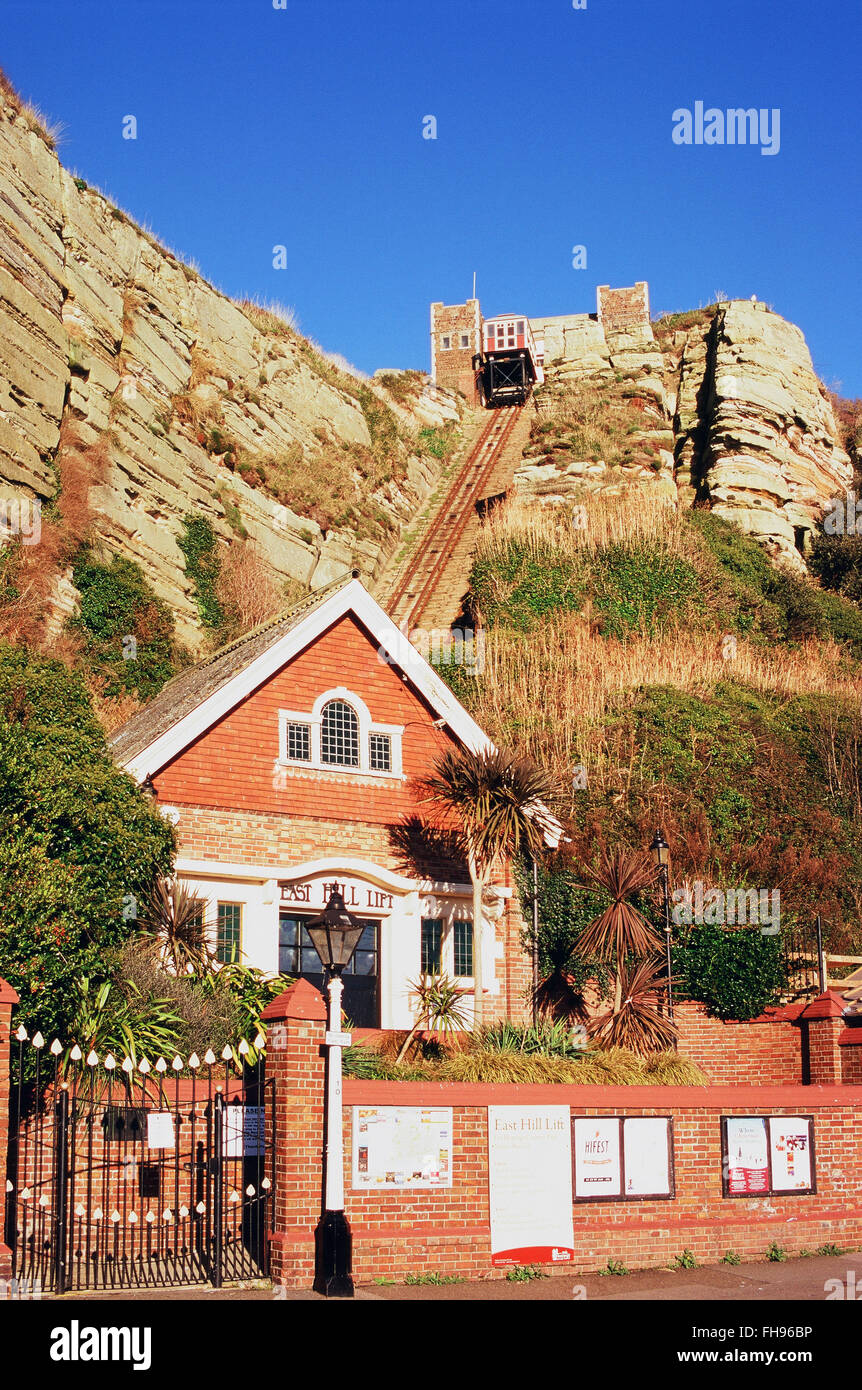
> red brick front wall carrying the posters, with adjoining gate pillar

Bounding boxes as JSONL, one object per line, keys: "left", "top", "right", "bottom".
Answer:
{"left": 267, "top": 987, "right": 862, "bottom": 1287}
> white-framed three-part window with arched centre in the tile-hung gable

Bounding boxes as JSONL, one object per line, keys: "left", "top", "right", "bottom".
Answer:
{"left": 278, "top": 687, "right": 403, "bottom": 777}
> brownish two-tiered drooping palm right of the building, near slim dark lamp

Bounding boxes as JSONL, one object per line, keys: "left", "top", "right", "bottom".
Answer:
{"left": 577, "top": 847, "right": 662, "bottom": 1013}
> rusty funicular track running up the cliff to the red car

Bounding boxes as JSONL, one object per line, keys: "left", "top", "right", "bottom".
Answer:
{"left": 387, "top": 406, "right": 524, "bottom": 626}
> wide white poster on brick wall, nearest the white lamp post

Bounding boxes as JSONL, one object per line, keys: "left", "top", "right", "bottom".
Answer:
{"left": 353, "top": 1105, "right": 452, "bottom": 1191}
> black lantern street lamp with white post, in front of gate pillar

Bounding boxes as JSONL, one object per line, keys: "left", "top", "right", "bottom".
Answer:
{"left": 306, "top": 892, "right": 363, "bottom": 1298}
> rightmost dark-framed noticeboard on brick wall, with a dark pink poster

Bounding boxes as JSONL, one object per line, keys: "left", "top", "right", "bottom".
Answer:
{"left": 722, "top": 1115, "right": 816, "bottom": 1197}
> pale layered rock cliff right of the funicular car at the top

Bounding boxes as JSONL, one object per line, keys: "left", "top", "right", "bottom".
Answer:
{"left": 514, "top": 300, "right": 852, "bottom": 570}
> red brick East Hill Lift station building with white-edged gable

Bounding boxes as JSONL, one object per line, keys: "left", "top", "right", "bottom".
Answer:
{"left": 113, "top": 578, "right": 553, "bottom": 1027}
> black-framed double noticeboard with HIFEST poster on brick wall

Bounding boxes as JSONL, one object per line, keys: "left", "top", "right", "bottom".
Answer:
{"left": 571, "top": 1115, "right": 674, "bottom": 1202}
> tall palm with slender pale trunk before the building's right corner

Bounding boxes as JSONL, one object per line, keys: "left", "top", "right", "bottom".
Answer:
{"left": 423, "top": 746, "right": 560, "bottom": 1027}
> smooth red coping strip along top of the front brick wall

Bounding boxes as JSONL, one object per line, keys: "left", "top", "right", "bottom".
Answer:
{"left": 343, "top": 1076, "right": 862, "bottom": 1111}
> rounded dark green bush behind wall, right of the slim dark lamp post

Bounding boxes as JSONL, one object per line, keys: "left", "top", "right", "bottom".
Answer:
{"left": 673, "top": 924, "right": 787, "bottom": 1020}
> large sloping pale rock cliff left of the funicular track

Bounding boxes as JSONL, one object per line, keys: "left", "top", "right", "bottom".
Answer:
{"left": 0, "top": 97, "right": 460, "bottom": 645}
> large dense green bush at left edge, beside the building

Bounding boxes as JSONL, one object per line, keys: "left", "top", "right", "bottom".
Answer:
{"left": 0, "top": 644, "right": 174, "bottom": 1036}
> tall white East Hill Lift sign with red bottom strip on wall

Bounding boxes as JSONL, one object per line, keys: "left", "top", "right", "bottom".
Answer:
{"left": 488, "top": 1105, "right": 574, "bottom": 1266}
